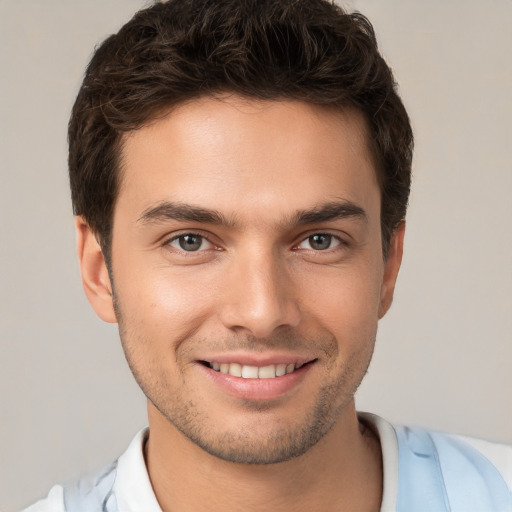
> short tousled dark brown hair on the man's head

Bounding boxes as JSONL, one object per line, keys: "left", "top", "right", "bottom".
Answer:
{"left": 69, "top": 0, "right": 413, "bottom": 263}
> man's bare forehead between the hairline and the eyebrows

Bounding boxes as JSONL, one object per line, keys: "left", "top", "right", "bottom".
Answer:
{"left": 116, "top": 96, "right": 380, "bottom": 224}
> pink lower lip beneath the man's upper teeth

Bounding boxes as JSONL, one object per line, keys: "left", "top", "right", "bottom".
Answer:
{"left": 200, "top": 363, "right": 313, "bottom": 400}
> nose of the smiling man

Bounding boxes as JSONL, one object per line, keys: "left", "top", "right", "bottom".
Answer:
{"left": 220, "top": 247, "right": 300, "bottom": 338}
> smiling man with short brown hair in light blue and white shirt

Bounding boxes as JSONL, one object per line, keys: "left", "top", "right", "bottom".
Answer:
{"left": 23, "top": 0, "right": 512, "bottom": 511}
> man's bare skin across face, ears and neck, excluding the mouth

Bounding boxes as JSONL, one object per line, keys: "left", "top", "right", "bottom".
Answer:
{"left": 77, "top": 96, "right": 404, "bottom": 511}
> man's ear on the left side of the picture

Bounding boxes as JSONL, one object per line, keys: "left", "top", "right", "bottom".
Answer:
{"left": 75, "top": 217, "right": 117, "bottom": 323}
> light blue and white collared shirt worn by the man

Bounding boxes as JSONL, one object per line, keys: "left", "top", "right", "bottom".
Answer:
{"left": 24, "top": 413, "right": 512, "bottom": 512}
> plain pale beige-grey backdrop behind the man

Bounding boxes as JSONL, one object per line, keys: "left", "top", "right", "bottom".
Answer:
{"left": 0, "top": 0, "right": 512, "bottom": 511}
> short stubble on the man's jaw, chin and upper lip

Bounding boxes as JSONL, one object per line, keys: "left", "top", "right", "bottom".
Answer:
{"left": 113, "top": 292, "right": 375, "bottom": 465}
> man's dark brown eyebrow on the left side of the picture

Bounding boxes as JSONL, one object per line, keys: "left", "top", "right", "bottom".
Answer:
{"left": 137, "top": 201, "right": 234, "bottom": 227}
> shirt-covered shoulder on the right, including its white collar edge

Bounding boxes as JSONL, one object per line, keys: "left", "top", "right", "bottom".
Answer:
{"left": 358, "top": 413, "right": 512, "bottom": 512}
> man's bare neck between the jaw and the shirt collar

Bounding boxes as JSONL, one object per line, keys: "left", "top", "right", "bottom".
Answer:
{"left": 145, "top": 402, "right": 382, "bottom": 512}
